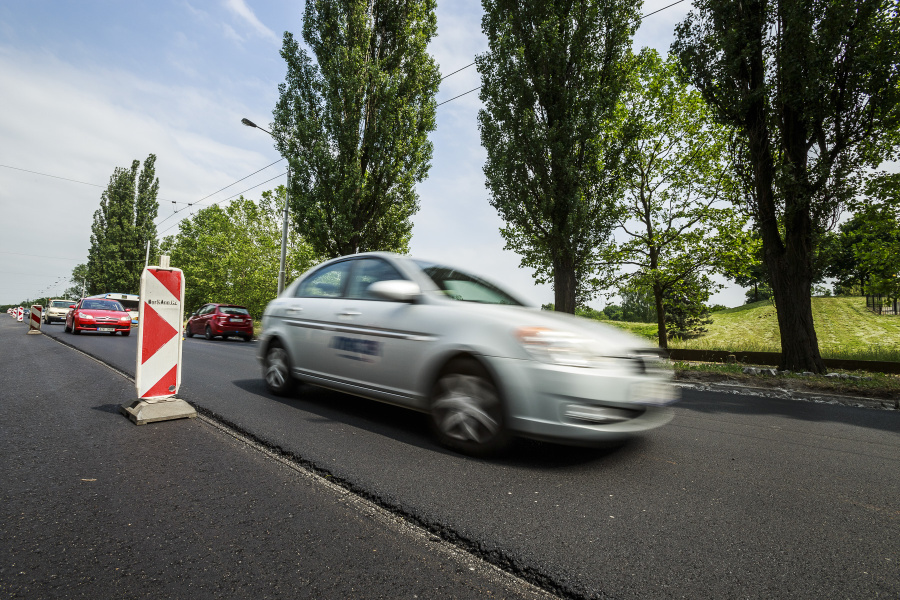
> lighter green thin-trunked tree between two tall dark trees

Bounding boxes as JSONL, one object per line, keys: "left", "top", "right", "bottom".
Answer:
{"left": 605, "top": 49, "right": 746, "bottom": 348}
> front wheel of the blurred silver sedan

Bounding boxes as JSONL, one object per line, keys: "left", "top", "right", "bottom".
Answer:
{"left": 431, "top": 359, "right": 510, "bottom": 456}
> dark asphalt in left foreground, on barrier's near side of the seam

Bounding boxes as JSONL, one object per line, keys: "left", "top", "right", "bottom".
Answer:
{"left": 0, "top": 319, "right": 541, "bottom": 599}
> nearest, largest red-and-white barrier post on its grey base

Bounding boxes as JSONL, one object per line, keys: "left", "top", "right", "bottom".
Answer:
{"left": 121, "top": 256, "right": 197, "bottom": 425}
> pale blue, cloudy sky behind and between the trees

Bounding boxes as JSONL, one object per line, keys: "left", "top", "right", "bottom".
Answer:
{"left": 0, "top": 0, "right": 744, "bottom": 308}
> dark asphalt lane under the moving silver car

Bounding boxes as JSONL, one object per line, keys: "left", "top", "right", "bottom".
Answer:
{"left": 15, "top": 316, "right": 900, "bottom": 599}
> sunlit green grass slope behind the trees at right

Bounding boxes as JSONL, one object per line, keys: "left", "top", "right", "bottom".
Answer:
{"left": 606, "top": 297, "right": 900, "bottom": 362}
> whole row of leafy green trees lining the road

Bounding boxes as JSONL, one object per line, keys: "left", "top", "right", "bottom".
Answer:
{"left": 59, "top": 0, "right": 900, "bottom": 372}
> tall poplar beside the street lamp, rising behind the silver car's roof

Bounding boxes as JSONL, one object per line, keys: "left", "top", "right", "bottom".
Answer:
{"left": 272, "top": 0, "right": 440, "bottom": 257}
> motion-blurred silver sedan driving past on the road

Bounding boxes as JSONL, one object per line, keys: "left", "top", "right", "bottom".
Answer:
{"left": 259, "top": 252, "right": 678, "bottom": 455}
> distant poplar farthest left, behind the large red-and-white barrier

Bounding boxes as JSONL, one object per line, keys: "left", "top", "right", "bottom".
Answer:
{"left": 87, "top": 154, "right": 159, "bottom": 294}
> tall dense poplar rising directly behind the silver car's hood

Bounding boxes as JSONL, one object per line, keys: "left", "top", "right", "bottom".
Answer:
{"left": 475, "top": 0, "right": 640, "bottom": 313}
